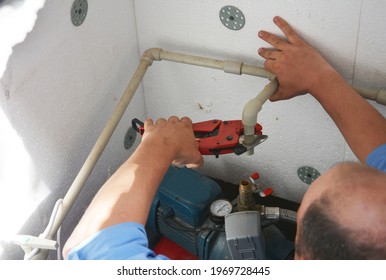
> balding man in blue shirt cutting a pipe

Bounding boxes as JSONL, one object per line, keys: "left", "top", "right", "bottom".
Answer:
{"left": 63, "top": 17, "right": 386, "bottom": 259}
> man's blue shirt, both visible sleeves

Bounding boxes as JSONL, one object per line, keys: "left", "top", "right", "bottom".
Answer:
{"left": 68, "top": 144, "right": 386, "bottom": 260}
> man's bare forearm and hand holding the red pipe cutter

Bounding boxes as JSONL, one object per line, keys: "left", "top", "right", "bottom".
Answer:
{"left": 63, "top": 116, "right": 203, "bottom": 258}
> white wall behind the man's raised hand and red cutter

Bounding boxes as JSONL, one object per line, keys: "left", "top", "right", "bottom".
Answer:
{"left": 135, "top": 0, "right": 386, "bottom": 201}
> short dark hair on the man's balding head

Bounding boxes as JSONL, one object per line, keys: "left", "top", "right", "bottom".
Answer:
{"left": 295, "top": 198, "right": 386, "bottom": 260}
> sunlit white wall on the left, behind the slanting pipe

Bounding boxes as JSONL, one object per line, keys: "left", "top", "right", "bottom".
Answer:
{"left": 0, "top": 0, "right": 145, "bottom": 259}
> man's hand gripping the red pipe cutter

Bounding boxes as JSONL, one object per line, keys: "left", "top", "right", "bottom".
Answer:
{"left": 141, "top": 116, "right": 203, "bottom": 168}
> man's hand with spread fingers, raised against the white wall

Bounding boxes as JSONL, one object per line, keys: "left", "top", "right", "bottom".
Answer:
{"left": 259, "top": 16, "right": 337, "bottom": 101}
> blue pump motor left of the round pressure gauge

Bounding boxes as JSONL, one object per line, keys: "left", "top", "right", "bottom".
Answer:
{"left": 146, "top": 167, "right": 292, "bottom": 260}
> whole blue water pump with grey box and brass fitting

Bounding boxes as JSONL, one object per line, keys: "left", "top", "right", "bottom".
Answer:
{"left": 146, "top": 167, "right": 296, "bottom": 260}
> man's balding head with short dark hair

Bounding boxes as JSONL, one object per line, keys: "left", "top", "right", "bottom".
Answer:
{"left": 295, "top": 163, "right": 386, "bottom": 259}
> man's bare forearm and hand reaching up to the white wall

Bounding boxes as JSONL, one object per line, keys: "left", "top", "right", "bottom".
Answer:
{"left": 259, "top": 17, "right": 386, "bottom": 162}
